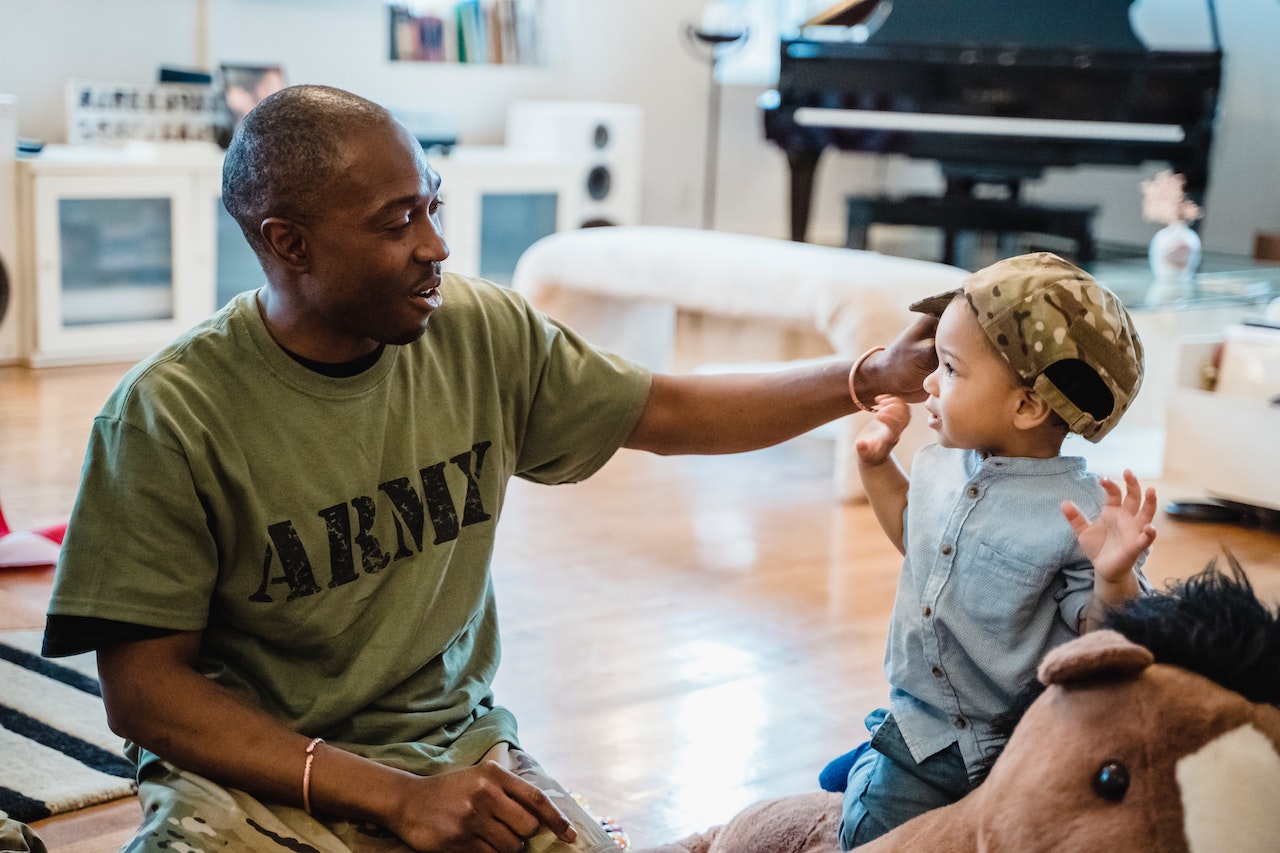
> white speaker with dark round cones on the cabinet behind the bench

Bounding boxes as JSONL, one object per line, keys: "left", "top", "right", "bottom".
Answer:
{"left": 507, "top": 101, "right": 644, "bottom": 228}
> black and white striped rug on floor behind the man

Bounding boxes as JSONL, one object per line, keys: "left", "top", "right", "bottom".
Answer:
{"left": 0, "top": 631, "right": 134, "bottom": 824}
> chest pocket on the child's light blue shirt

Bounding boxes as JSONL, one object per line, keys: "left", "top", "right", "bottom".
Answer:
{"left": 952, "top": 542, "right": 1047, "bottom": 635}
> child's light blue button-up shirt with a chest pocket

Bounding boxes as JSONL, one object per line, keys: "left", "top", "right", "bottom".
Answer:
{"left": 884, "top": 444, "right": 1147, "bottom": 772}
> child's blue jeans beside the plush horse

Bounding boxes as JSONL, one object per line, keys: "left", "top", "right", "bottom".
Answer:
{"left": 840, "top": 708, "right": 969, "bottom": 850}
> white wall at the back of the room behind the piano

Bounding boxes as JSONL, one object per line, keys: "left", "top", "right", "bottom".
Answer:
{"left": 0, "top": 0, "right": 1280, "bottom": 252}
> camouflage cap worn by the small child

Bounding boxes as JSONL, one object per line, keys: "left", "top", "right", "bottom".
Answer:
{"left": 911, "top": 252, "right": 1143, "bottom": 442}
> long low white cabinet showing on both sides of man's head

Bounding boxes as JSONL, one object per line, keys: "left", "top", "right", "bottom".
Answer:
{"left": 0, "top": 143, "right": 582, "bottom": 366}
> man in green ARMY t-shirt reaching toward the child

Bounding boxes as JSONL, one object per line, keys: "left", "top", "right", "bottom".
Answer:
{"left": 45, "top": 86, "right": 933, "bottom": 853}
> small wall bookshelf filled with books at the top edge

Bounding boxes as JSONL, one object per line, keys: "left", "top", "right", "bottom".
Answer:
{"left": 387, "top": 0, "right": 545, "bottom": 65}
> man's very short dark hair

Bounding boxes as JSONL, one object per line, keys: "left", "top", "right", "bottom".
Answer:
{"left": 223, "top": 86, "right": 394, "bottom": 257}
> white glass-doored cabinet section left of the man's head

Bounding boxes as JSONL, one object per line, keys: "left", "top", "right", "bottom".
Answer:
{"left": 18, "top": 145, "right": 252, "bottom": 366}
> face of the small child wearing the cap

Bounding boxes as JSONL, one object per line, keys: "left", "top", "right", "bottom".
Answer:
{"left": 924, "top": 297, "right": 1027, "bottom": 456}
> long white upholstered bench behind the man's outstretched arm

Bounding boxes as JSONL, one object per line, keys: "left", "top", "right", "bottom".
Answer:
{"left": 512, "top": 225, "right": 968, "bottom": 500}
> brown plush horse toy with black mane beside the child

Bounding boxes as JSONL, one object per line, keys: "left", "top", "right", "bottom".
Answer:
{"left": 640, "top": 564, "right": 1280, "bottom": 853}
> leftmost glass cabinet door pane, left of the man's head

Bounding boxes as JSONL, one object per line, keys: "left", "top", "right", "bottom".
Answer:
{"left": 58, "top": 197, "right": 174, "bottom": 328}
